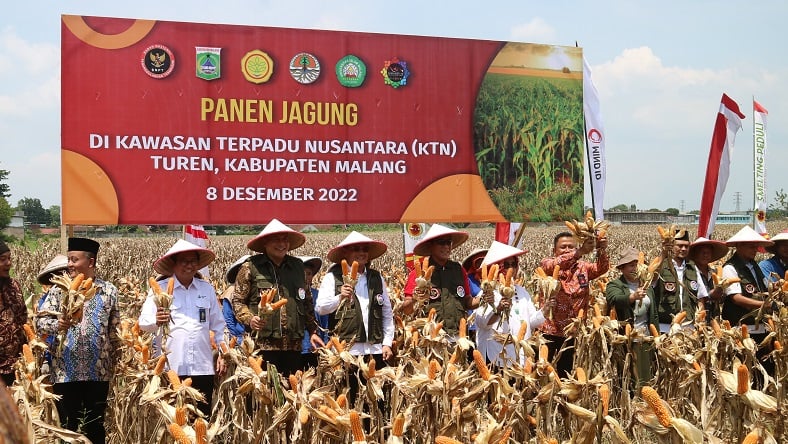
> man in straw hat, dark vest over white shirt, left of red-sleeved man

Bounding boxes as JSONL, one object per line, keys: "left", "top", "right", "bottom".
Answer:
{"left": 317, "top": 231, "right": 394, "bottom": 402}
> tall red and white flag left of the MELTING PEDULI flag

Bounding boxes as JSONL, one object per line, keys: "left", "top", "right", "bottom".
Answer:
{"left": 698, "top": 94, "right": 744, "bottom": 239}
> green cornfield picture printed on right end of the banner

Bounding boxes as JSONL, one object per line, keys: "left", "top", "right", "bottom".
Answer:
{"left": 474, "top": 73, "right": 585, "bottom": 222}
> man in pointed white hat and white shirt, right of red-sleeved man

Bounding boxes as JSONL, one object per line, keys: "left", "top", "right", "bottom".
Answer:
{"left": 476, "top": 241, "right": 545, "bottom": 368}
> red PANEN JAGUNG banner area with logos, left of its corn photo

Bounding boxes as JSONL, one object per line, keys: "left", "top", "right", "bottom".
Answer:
{"left": 62, "top": 15, "right": 582, "bottom": 224}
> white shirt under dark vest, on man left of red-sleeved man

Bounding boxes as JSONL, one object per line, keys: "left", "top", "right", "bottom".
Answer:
{"left": 315, "top": 271, "right": 394, "bottom": 355}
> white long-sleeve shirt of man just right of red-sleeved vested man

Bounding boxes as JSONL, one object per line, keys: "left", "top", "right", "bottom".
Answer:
{"left": 476, "top": 285, "right": 545, "bottom": 367}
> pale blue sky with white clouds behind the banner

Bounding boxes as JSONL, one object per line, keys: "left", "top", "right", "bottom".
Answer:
{"left": 0, "top": 0, "right": 788, "bottom": 215}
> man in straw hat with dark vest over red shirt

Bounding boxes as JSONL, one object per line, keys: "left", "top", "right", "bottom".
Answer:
{"left": 402, "top": 224, "right": 478, "bottom": 336}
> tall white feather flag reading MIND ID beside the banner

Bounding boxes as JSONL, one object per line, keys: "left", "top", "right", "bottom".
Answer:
{"left": 583, "top": 57, "right": 607, "bottom": 219}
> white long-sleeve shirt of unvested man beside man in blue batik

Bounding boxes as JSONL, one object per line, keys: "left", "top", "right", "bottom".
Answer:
{"left": 139, "top": 278, "right": 225, "bottom": 376}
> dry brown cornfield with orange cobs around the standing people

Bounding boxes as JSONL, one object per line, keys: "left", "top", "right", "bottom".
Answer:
{"left": 6, "top": 224, "right": 788, "bottom": 444}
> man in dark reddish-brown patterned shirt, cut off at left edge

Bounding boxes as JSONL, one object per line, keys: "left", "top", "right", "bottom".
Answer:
{"left": 0, "top": 239, "right": 27, "bottom": 386}
